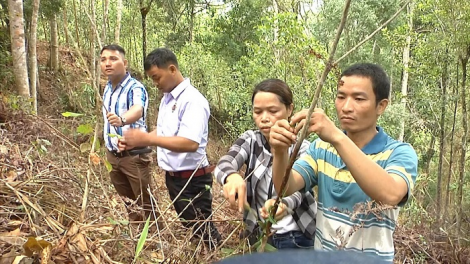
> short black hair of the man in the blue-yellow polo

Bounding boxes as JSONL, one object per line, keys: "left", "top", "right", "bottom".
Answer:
{"left": 341, "top": 63, "right": 390, "bottom": 105}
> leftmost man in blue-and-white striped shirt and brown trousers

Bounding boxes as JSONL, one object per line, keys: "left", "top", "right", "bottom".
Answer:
{"left": 100, "top": 45, "right": 152, "bottom": 221}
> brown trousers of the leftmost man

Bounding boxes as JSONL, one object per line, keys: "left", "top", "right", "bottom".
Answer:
{"left": 106, "top": 150, "right": 153, "bottom": 221}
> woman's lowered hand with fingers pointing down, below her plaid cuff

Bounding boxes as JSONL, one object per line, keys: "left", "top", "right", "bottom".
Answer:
{"left": 224, "top": 173, "right": 248, "bottom": 213}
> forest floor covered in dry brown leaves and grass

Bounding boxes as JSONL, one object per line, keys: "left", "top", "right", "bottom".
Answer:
{"left": 0, "top": 44, "right": 470, "bottom": 264}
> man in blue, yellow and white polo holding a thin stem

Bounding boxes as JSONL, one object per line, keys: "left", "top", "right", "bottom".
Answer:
{"left": 270, "top": 63, "right": 418, "bottom": 262}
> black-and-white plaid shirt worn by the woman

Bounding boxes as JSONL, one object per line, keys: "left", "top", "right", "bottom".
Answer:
{"left": 214, "top": 130, "right": 317, "bottom": 238}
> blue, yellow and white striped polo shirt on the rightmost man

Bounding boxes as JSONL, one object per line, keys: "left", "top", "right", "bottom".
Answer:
{"left": 293, "top": 127, "right": 418, "bottom": 262}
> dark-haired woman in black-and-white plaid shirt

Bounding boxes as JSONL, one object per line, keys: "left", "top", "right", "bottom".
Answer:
{"left": 215, "top": 79, "right": 317, "bottom": 249}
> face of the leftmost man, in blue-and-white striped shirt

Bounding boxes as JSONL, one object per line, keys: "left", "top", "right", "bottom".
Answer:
{"left": 100, "top": 50, "right": 127, "bottom": 79}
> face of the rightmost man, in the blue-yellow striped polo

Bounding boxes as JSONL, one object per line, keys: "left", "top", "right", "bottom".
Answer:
{"left": 335, "top": 75, "right": 388, "bottom": 133}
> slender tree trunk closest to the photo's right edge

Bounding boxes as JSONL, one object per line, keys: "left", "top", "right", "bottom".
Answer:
{"left": 457, "top": 51, "right": 470, "bottom": 244}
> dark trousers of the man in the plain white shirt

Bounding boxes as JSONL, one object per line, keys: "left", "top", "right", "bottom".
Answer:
{"left": 165, "top": 172, "right": 220, "bottom": 243}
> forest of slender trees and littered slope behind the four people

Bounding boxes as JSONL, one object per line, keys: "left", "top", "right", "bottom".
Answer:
{"left": 0, "top": 0, "right": 470, "bottom": 263}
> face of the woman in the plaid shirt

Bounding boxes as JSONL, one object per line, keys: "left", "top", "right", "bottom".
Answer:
{"left": 253, "top": 92, "right": 293, "bottom": 139}
